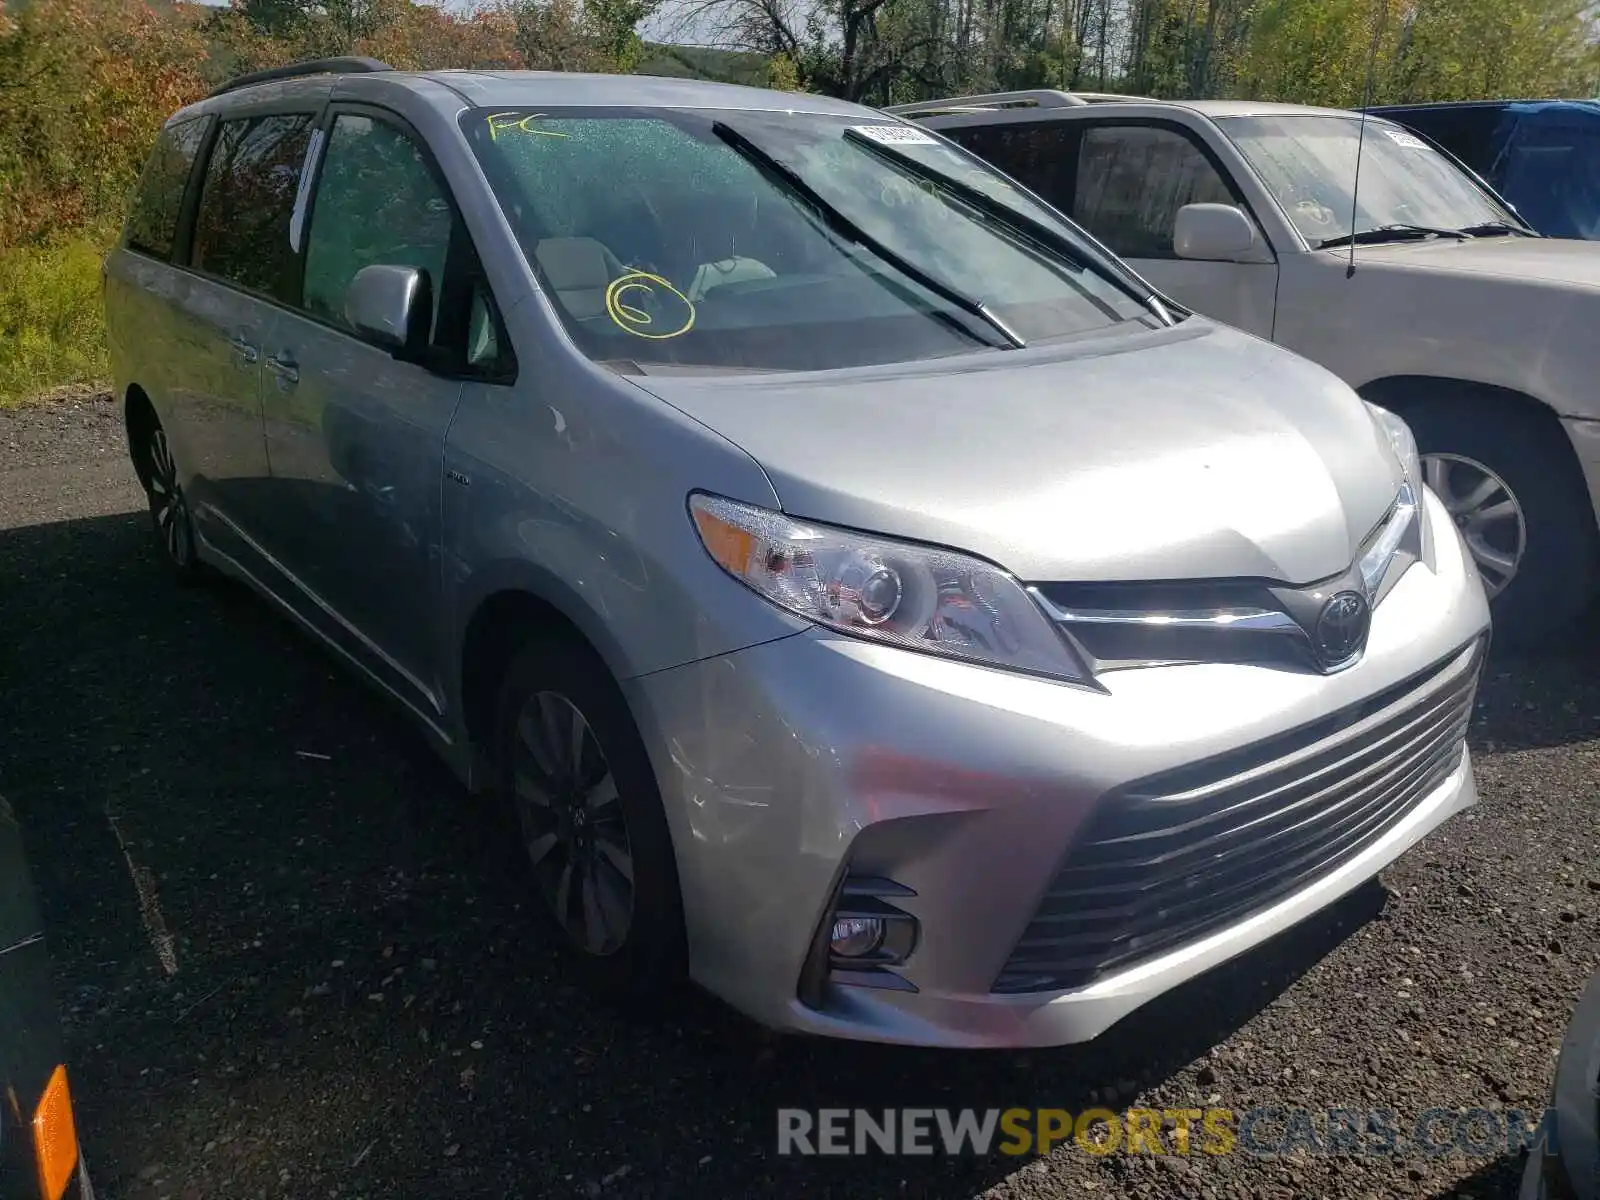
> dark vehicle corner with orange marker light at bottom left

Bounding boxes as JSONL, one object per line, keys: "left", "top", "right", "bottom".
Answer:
{"left": 0, "top": 797, "right": 94, "bottom": 1200}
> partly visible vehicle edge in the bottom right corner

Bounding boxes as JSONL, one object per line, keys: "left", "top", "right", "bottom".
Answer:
{"left": 1520, "top": 974, "right": 1600, "bottom": 1200}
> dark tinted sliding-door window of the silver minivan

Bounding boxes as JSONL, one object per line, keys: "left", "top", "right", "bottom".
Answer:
{"left": 192, "top": 112, "right": 312, "bottom": 298}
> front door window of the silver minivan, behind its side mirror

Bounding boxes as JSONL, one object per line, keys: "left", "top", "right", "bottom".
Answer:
{"left": 304, "top": 114, "right": 454, "bottom": 336}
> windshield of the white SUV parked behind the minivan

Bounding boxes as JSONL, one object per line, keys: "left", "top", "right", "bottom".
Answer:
{"left": 1218, "top": 115, "right": 1517, "bottom": 246}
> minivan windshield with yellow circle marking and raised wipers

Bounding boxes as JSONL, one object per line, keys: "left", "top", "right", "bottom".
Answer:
{"left": 462, "top": 109, "right": 1150, "bottom": 370}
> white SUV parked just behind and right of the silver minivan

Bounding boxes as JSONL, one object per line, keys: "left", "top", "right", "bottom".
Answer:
{"left": 891, "top": 91, "right": 1600, "bottom": 643}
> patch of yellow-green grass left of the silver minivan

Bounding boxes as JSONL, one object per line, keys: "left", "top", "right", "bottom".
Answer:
{"left": 0, "top": 237, "right": 110, "bottom": 408}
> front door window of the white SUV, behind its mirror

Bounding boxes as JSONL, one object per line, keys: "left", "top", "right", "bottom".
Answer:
{"left": 1072, "top": 125, "right": 1235, "bottom": 258}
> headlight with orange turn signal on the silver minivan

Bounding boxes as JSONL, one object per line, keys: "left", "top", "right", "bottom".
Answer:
{"left": 690, "top": 494, "right": 1091, "bottom": 683}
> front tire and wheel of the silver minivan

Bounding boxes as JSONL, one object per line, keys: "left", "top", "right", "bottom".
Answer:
{"left": 496, "top": 637, "right": 686, "bottom": 998}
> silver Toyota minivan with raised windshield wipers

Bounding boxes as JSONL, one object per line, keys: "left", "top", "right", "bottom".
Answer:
{"left": 107, "top": 61, "right": 1488, "bottom": 1046}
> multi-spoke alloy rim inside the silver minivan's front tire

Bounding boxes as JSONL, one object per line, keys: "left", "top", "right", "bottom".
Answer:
{"left": 512, "top": 691, "right": 634, "bottom": 957}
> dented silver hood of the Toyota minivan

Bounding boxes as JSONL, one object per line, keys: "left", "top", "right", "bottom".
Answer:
{"left": 630, "top": 317, "right": 1400, "bottom": 584}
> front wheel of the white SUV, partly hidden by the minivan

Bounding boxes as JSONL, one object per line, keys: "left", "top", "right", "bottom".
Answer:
{"left": 1397, "top": 395, "right": 1600, "bottom": 648}
